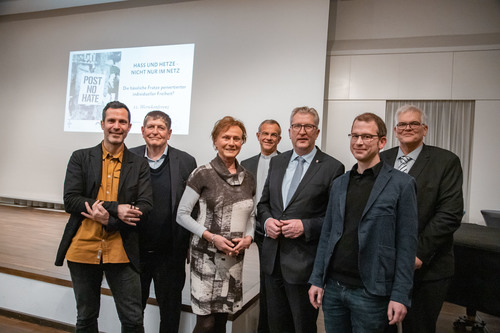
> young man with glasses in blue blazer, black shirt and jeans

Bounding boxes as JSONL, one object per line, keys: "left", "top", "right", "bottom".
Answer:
{"left": 309, "top": 113, "right": 417, "bottom": 333}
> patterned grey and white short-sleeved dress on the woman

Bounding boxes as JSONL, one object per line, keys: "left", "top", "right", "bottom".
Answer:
{"left": 178, "top": 155, "right": 256, "bottom": 315}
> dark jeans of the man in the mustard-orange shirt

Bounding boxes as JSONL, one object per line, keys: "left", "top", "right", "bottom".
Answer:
{"left": 68, "top": 261, "right": 144, "bottom": 333}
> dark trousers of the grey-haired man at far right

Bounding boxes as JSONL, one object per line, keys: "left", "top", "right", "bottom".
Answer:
{"left": 403, "top": 278, "right": 452, "bottom": 333}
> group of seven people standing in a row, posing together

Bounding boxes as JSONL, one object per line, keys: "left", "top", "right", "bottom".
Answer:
{"left": 56, "top": 101, "right": 463, "bottom": 333}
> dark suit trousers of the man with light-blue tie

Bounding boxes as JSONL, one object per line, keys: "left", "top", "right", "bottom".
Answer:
{"left": 265, "top": 260, "right": 318, "bottom": 333}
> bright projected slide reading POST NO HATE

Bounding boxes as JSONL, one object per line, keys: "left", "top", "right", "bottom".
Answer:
{"left": 64, "top": 44, "right": 194, "bottom": 134}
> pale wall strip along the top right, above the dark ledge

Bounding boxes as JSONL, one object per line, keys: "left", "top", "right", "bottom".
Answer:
{"left": 330, "top": 0, "right": 500, "bottom": 41}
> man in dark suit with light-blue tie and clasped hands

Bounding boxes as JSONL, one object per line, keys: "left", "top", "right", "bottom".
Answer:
{"left": 257, "top": 107, "right": 344, "bottom": 333}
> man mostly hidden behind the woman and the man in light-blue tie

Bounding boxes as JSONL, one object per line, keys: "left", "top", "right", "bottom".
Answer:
{"left": 241, "top": 119, "right": 281, "bottom": 333}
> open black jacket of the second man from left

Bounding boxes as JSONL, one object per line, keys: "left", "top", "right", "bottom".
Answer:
{"left": 130, "top": 145, "right": 196, "bottom": 260}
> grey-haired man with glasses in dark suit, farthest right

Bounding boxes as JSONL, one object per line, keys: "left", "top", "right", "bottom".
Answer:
{"left": 380, "top": 105, "right": 464, "bottom": 333}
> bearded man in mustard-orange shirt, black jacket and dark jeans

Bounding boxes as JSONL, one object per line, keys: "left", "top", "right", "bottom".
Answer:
{"left": 55, "top": 101, "right": 153, "bottom": 332}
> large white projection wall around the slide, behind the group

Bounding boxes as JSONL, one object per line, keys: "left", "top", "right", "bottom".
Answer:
{"left": 0, "top": 0, "right": 329, "bottom": 202}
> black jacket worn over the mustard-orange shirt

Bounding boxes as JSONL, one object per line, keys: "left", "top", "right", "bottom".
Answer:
{"left": 55, "top": 144, "right": 153, "bottom": 270}
